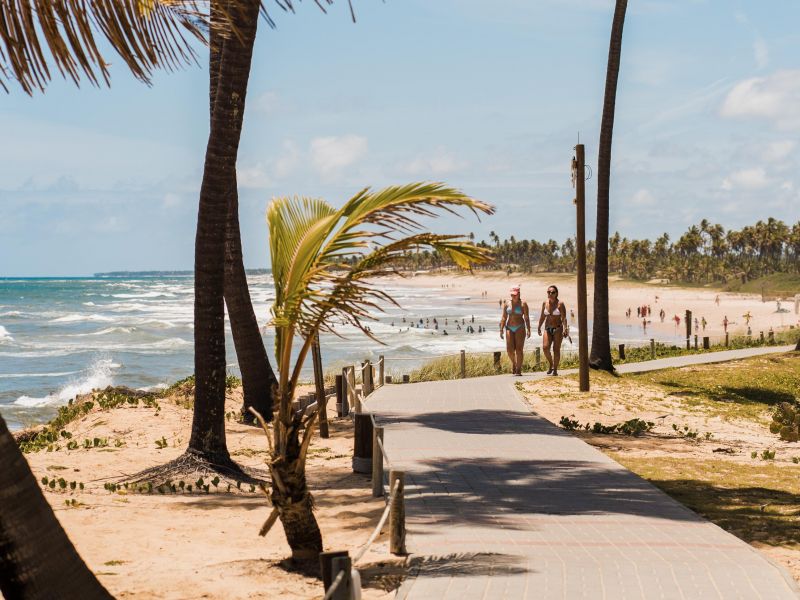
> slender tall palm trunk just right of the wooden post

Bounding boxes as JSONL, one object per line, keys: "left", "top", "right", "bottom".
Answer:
{"left": 589, "top": 0, "right": 628, "bottom": 371}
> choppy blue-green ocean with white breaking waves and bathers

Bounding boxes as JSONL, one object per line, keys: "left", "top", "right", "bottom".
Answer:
{"left": 0, "top": 274, "right": 668, "bottom": 429}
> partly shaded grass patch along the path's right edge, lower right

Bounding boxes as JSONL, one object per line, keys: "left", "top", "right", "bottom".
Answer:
{"left": 608, "top": 452, "right": 800, "bottom": 548}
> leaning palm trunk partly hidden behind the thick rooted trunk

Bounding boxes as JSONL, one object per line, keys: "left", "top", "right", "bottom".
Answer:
{"left": 209, "top": 2, "right": 277, "bottom": 422}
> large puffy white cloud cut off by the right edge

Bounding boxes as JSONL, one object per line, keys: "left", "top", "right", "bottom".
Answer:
{"left": 720, "top": 70, "right": 800, "bottom": 131}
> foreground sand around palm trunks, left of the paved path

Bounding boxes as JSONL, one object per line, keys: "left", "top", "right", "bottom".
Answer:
{"left": 25, "top": 391, "right": 402, "bottom": 599}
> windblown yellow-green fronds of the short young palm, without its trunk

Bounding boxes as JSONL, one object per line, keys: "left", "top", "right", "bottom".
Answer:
{"left": 267, "top": 183, "right": 494, "bottom": 381}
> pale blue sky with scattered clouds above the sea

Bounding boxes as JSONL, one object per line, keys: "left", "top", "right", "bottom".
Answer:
{"left": 0, "top": 0, "right": 800, "bottom": 276}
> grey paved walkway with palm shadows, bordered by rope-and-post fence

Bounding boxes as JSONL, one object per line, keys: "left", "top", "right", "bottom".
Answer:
{"left": 367, "top": 349, "right": 800, "bottom": 600}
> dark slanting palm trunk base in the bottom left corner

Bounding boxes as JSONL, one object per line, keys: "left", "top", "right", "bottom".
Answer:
{"left": 0, "top": 417, "right": 112, "bottom": 600}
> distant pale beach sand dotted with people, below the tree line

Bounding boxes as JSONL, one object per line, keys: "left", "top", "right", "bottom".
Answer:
{"left": 388, "top": 271, "right": 800, "bottom": 344}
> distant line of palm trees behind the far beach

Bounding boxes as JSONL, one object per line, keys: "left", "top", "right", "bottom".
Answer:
{"left": 378, "top": 217, "right": 800, "bottom": 283}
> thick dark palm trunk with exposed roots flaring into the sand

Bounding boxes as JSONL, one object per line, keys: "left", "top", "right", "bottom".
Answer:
{"left": 188, "top": 0, "right": 259, "bottom": 465}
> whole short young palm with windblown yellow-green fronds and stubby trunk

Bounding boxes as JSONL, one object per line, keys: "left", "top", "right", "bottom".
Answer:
{"left": 259, "top": 183, "right": 494, "bottom": 560}
